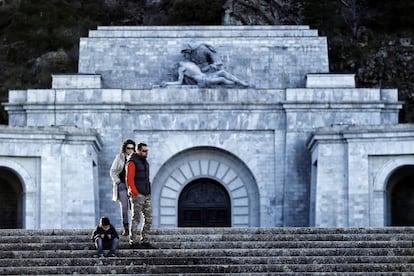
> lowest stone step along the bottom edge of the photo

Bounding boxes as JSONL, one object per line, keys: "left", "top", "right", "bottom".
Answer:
{"left": 0, "top": 263, "right": 414, "bottom": 275}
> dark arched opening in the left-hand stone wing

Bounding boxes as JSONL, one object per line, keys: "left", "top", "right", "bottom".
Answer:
{"left": 0, "top": 167, "right": 23, "bottom": 229}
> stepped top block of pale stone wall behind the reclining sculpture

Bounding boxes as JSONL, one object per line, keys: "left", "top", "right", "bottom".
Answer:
{"left": 79, "top": 26, "right": 329, "bottom": 89}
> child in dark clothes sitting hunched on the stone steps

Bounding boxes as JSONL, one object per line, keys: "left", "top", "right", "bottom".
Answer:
{"left": 91, "top": 217, "right": 119, "bottom": 258}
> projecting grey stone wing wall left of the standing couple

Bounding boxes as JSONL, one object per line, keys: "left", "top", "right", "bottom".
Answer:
{"left": 0, "top": 126, "right": 101, "bottom": 229}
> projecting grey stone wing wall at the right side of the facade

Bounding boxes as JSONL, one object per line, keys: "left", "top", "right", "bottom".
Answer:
{"left": 309, "top": 124, "right": 414, "bottom": 227}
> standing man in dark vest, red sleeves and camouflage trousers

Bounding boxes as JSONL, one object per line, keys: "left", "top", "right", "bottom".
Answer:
{"left": 126, "top": 143, "right": 154, "bottom": 248}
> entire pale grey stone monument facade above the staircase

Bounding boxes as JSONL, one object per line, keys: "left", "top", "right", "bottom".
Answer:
{"left": 0, "top": 26, "right": 414, "bottom": 228}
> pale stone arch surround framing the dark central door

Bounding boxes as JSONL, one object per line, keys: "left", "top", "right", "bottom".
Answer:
{"left": 151, "top": 147, "right": 260, "bottom": 228}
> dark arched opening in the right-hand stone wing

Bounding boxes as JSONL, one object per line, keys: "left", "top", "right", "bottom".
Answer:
{"left": 389, "top": 166, "right": 414, "bottom": 226}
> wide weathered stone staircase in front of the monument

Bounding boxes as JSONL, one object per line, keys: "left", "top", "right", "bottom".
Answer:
{"left": 0, "top": 227, "right": 414, "bottom": 275}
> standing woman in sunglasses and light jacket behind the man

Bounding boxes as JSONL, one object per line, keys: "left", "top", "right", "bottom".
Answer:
{"left": 109, "top": 139, "right": 135, "bottom": 236}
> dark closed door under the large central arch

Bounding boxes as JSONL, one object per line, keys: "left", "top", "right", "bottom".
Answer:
{"left": 178, "top": 178, "right": 231, "bottom": 227}
